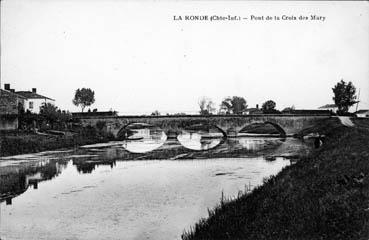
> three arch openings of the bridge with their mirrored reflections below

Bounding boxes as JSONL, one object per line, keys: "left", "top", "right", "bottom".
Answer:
{"left": 122, "top": 124, "right": 294, "bottom": 153}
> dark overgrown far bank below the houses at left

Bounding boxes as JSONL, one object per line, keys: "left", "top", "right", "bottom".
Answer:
{"left": 0, "top": 128, "right": 110, "bottom": 157}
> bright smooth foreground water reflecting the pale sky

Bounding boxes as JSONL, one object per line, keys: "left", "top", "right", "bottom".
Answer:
{"left": 0, "top": 158, "right": 288, "bottom": 240}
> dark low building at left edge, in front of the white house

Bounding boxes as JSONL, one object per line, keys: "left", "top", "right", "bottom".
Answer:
{"left": 0, "top": 89, "right": 26, "bottom": 130}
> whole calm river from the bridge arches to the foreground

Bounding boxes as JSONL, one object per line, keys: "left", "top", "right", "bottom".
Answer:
{"left": 0, "top": 133, "right": 312, "bottom": 240}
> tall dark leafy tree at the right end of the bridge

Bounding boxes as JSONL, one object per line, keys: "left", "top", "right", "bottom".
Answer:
{"left": 332, "top": 79, "right": 357, "bottom": 114}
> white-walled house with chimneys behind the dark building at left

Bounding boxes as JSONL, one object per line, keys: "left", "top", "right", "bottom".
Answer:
{"left": 4, "top": 83, "right": 55, "bottom": 113}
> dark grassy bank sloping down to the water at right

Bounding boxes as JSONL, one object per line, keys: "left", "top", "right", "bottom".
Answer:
{"left": 182, "top": 120, "right": 369, "bottom": 240}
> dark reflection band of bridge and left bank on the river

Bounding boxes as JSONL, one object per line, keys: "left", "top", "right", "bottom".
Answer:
{"left": 0, "top": 136, "right": 312, "bottom": 207}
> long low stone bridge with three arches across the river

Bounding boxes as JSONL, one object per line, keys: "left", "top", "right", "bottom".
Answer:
{"left": 76, "top": 114, "right": 330, "bottom": 137}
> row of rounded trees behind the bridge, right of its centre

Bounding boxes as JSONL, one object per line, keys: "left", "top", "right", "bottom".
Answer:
{"left": 199, "top": 96, "right": 279, "bottom": 115}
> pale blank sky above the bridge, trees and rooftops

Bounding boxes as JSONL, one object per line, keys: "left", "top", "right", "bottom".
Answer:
{"left": 1, "top": 0, "right": 369, "bottom": 114}
